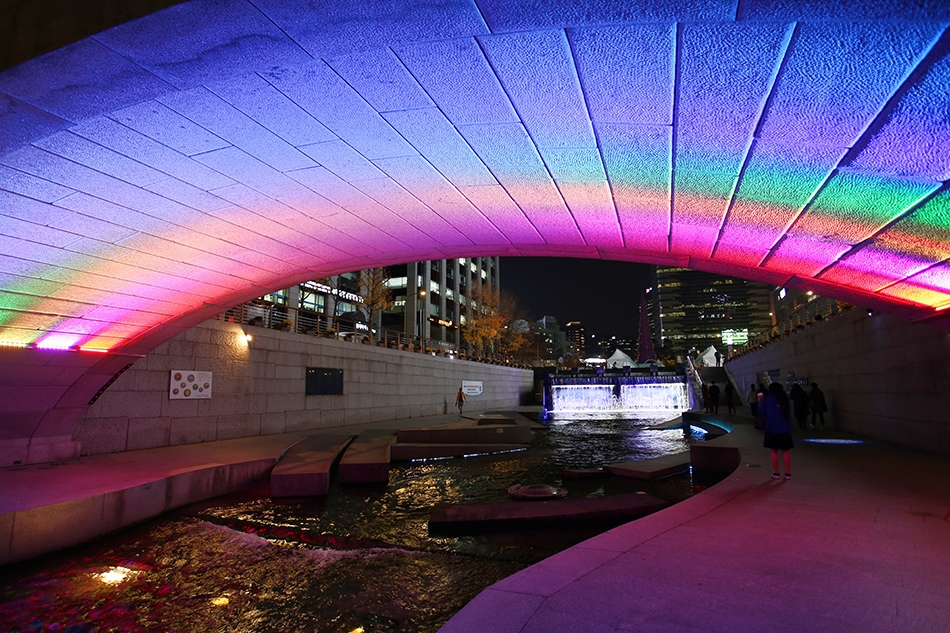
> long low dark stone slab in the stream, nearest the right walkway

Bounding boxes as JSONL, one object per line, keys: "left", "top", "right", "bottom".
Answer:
{"left": 429, "top": 492, "right": 669, "bottom": 531}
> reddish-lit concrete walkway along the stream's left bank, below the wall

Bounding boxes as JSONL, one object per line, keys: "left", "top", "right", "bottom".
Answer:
{"left": 0, "top": 414, "right": 477, "bottom": 565}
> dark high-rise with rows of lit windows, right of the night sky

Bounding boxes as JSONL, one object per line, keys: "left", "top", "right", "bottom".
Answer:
{"left": 651, "top": 267, "right": 772, "bottom": 356}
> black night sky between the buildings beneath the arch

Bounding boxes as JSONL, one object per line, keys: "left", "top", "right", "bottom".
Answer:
{"left": 501, "top": 257, "right": 650, "bottom": 338}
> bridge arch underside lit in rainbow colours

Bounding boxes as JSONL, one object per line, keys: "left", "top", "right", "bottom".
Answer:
{"left": 0, "top": 0, "right": 950, "bottom": 454}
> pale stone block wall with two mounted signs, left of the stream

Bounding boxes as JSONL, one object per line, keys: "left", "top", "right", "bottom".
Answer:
{"left": 74, "top": 321, "right": 533, "bottom": 455}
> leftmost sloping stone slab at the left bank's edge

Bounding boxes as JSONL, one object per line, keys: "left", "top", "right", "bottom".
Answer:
{"left": 270, "top": 433, "right": 356, "bottom": 497}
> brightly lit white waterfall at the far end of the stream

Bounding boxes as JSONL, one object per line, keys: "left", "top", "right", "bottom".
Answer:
{"left": 544, "top": 374, "right": 690, "bottom": 417}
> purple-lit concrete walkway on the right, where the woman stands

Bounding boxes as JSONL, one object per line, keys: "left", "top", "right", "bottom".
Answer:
{"left": 440, "top": 418, "right": 950, "bottom": 633}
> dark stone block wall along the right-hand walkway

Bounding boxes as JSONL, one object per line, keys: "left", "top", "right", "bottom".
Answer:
{"left": 726, "top": 309, "right": 950, "bottom": 455}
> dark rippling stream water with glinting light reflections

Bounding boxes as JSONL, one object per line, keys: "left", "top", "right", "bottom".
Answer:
{"left": 0, "top": 419, "right": 712, "bottom": 633}
